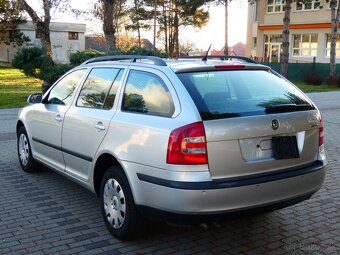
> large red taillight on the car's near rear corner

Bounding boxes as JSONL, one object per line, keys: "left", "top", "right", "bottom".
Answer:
{"left": 167, "top": 122, "right": 208, "bottom": 165}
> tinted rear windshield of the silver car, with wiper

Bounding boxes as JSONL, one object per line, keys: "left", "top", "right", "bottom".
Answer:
{"left": 177, "top": 70, "right": 314, "bottom": 120}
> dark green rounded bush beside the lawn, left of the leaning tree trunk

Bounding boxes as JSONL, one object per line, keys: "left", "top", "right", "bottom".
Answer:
{"left": 12, "top": 47, "right": 53, "bottom": 78}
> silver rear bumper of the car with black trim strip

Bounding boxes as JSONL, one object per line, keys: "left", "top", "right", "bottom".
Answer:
{"left": 136, "top": 161, "right": 326, "bottom": 215}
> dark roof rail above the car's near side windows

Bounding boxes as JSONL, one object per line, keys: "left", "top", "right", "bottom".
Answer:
{"left": 81, "top": 55, "right": 167, "bottom": 66}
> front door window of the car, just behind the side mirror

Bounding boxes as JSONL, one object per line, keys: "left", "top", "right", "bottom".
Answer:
{"left": 46, "top": 69, "right": 86, "bottom": 105}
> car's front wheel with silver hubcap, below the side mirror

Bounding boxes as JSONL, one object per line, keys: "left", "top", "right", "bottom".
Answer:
{"left": 17, "top": 127, "right": 42, "bottom": 173}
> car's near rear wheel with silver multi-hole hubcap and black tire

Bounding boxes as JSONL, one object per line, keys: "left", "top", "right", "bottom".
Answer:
{"left": 100, "top": 166, "right": 145, "bottom": 240}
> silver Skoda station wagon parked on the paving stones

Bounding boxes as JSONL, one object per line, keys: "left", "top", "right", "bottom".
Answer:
{"left": 16, "top": 56, "right": 327, "bottom": 239}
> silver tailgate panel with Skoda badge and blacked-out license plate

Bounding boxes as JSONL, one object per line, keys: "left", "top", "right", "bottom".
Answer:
{"left": 204, "top": 110, "right": 320, "bottom": 180}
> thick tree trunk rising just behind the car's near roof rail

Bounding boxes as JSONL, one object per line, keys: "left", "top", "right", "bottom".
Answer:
{"left": 103, "top": 0, "right": 116, "bottom": 50}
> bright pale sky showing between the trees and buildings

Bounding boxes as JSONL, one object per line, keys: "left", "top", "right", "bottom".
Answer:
{"left": 23, "top": 0, "right": 248, "bottom": 50}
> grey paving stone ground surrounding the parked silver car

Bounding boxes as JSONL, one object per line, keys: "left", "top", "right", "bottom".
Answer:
{"left": 0, "top": 92, "right": 340, "bottom": 255}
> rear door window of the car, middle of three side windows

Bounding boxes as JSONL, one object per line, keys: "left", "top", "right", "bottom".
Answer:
{"left": 76, "top": 68, "right": 121, "bottom": 109}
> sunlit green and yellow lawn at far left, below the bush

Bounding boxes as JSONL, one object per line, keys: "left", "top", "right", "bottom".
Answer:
{"left": 0, "top": 67, "right": 42, "bottom": 108}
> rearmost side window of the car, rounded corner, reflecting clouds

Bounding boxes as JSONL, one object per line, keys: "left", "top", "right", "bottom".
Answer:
{"left": 122, "top": 70, "right": 174, "bottom": 117}
